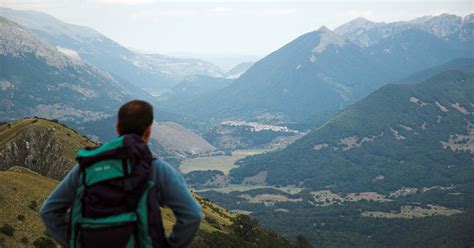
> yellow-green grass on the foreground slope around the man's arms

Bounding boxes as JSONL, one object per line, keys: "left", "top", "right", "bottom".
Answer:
{"left": 0, "top": 167, "right": 234, "bottom": 247}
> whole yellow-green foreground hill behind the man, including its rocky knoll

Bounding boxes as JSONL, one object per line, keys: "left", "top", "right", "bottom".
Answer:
{"left": 0, "top": 119, "right": 291, "bottom": 248}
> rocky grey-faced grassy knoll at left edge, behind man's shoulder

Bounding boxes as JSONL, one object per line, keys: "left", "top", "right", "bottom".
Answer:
{"left": 0, "top": 118, "right": 97, "bottom": 180}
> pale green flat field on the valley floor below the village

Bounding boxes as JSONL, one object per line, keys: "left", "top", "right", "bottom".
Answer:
{"left": 179, "top": 149, "right": 270, "bottom": 175}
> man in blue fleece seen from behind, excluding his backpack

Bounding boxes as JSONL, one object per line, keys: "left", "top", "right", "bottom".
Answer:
{"left": 40, "top": 100, "right": 202, "bottom": 247}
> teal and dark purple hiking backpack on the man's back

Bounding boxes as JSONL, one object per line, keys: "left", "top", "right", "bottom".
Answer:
{"left": 68, "top": 134, "right": 168, "bottom": 248}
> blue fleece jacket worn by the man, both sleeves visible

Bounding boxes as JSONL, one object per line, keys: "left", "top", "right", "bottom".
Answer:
{"left": 40, "top": 160, "right": 202, "bottom": 247}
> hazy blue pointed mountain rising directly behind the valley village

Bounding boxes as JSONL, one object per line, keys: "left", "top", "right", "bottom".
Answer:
{"left": 167, "top": 27, "right": 388, "bottom": 123}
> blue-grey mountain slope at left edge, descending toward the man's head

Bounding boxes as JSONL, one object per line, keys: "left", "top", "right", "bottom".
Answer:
{"left": 0, "top": 17, "right": 132, "bottom": 123}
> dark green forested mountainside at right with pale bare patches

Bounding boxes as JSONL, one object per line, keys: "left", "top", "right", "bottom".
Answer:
{"left": 230, "top": 71, "right": 474, "bottom": 192}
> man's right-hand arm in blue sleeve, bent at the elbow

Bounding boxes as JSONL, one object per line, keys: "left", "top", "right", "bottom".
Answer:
{"left": 153, "top": 161, "right": 202, "bottom": 247}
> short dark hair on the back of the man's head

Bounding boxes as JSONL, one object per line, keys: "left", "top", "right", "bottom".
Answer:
{"left": 118, "top": 100, "right": 153, "bottom": 136}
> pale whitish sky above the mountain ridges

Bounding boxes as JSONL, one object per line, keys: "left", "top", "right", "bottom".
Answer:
{"left": 0, "top": 0, "right": 474, "bottom": 66}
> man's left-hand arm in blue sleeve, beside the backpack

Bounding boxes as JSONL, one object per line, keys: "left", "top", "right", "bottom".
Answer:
{"left": 40, "top": 165, "right": 79, "bottom": 246}
